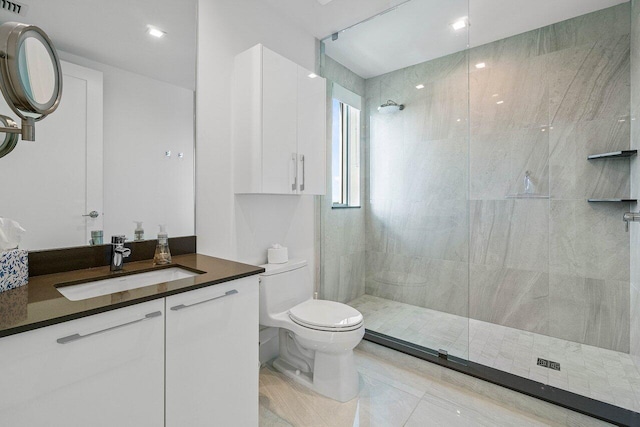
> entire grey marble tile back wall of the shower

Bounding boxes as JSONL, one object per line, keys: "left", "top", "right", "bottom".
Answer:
{"left": 366, "top": 3, "right": 631, "bottom": 352}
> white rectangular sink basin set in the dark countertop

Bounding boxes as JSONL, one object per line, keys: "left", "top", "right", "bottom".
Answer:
{"left": 57, "top": 267, "right": 198, "bottom": 301}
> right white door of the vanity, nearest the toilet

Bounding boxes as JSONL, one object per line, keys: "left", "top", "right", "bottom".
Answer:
{"left": 166, "top": 276, "right": 259, "bottom": 427}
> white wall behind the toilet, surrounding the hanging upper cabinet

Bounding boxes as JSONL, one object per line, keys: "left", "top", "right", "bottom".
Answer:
{"left": 196, "top": 0, "right": 317, "bottom": 271}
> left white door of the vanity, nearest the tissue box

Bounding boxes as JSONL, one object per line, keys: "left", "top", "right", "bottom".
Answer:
{"left": 0, "top": 300, "right": 164, "bottom": 427}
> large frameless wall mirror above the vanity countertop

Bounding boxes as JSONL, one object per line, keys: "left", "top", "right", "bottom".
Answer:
{"left": 0, "top": 0, "right": 197, "bottom": 250}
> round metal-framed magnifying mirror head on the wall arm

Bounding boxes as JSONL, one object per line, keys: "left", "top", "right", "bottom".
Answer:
{"left": 0, "top": 22, "right": 62, "bottom": 121}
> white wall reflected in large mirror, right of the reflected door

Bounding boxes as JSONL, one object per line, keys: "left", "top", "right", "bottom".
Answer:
{"left": 60, "top": 52, "right": 195, "bottom": 241}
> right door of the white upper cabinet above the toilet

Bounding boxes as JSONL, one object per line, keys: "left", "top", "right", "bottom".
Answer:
{"left": 298, "top": 67, "right": 327, "bottom": 194}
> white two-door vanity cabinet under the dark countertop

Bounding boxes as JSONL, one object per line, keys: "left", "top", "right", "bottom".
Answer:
{"left": 0, "top": 276, "right": 259, "bottom": 427}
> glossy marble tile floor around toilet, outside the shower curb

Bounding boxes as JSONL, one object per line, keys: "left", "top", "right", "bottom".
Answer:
{"left": 260, "top": 341, "right": 609, "bottom": 427}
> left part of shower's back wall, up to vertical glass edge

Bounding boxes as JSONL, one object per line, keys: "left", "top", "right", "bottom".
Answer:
{"left": 366, "top": 52, "right": 469, "bottom": 316}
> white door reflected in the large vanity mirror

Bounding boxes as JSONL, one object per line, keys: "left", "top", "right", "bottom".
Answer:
{"left": 0, "top": 61, "right": 103, "bottom": 250}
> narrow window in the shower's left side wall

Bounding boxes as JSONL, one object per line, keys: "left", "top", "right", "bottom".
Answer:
{"left": 331, "top": 99, "right": 360, "bottom": 208}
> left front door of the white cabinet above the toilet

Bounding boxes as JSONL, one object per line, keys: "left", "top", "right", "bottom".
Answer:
{"left": 262, "top": 48, "right": 298, "bottom": 194}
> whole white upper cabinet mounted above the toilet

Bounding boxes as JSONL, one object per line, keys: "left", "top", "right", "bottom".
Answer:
{"left": 233, "top": 45, "right": 326, "bottom": 194}
